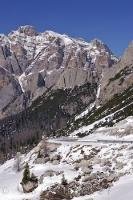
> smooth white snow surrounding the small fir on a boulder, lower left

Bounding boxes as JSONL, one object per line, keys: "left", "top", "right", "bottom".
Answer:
{"left": 0, "top": 142, "right": 77, "bottom": 200}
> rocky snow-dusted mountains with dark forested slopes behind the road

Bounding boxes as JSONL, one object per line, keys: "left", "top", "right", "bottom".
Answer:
{"left": 0, "top": 26, "right": 133, "bottom": 158}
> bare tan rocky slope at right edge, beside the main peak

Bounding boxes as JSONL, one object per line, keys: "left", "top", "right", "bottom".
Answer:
{"left": 97, "top": 42, "right": 133, "bottom": 104}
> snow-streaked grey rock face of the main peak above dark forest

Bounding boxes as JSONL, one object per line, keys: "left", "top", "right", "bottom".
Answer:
{"left": 0, "top": 25, "right": 118, "bottom": 118}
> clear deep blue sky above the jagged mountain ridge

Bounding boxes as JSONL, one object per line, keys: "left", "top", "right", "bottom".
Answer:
{"left": 0, "top": 0, "right": 133, "bottom": 55}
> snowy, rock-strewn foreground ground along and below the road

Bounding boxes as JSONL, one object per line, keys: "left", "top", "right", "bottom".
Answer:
{"left": 0, "top": 117, "right": 133, "bottom": 200}
